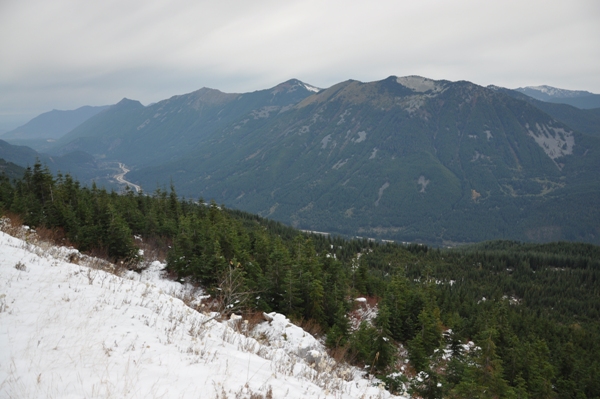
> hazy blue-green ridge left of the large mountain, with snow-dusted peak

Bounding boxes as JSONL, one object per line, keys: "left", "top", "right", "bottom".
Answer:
{"left": 54, "top": 79, "right": 319, "bottom": 166}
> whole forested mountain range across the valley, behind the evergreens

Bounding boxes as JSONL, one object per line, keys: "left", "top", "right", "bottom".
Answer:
{"left": 3, "top": 76, "right": 600, "bottom": 245}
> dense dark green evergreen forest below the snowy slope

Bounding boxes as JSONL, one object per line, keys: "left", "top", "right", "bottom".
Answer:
{"left": 0, "top": 163, "right": 600, "bottom": 398}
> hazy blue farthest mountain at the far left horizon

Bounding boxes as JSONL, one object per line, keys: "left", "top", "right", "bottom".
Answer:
{"left": 2, "top": 105, "right": 109, "bottom": 140}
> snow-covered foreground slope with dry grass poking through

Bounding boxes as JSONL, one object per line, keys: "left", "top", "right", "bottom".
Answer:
{"left": 0, "top": 228, "right": 406, "bottom": 398}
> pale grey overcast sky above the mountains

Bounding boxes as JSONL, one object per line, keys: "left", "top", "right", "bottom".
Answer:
{"left": 0, "top": 0, "right": 600, "bottom": 131}
